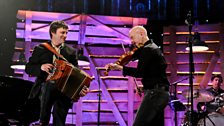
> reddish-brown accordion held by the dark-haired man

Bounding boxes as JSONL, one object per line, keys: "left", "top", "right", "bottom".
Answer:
{"left": 47, "top": 59, "right": 92, "bottom": 101}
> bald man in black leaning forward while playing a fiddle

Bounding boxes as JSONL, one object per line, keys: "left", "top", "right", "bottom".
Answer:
{"left": 105, "top": 26, "right": 169, "bottom": 126}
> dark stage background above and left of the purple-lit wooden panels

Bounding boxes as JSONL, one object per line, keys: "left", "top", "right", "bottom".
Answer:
{"left": 0, "top": 0, "right": 224, "bottom": 75}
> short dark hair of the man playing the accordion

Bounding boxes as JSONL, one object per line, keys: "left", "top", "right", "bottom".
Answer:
{"left": 49, "top": 21, "right": 68, "bottom": 38}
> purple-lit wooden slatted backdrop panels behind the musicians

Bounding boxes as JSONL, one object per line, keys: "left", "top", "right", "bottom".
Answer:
{"left": 13, "top": 10, "right": 224, "bottom": 126}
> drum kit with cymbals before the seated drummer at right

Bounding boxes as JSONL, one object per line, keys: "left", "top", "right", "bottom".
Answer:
{"left": 181, "top": 89, "right": 224, "bottom": 126}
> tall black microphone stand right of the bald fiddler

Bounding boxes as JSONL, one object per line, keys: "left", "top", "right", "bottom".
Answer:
{"left": 185, "top": 11, "right": 194, "bottom": 126}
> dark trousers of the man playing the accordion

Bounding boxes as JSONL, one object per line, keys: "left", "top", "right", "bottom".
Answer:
{"left": 40, "top": 83, "right": 72, "bottom": 126}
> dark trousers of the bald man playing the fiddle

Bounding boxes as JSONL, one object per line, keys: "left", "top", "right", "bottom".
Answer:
{"left": 133, "top": 89, "right": 169, "bottom": 126}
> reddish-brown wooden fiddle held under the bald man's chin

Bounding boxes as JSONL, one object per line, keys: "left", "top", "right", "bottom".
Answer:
{"left": 104, "top": 47, "right": 138, "bottom": 76}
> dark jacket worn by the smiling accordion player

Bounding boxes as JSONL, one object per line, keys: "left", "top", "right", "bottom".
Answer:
{"left": 25, "top": 42, "right": 78, "bottom": 99}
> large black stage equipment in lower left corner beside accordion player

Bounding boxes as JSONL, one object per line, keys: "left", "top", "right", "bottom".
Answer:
{"left": 0, "top": 76, "right": 40, "bottom": 126}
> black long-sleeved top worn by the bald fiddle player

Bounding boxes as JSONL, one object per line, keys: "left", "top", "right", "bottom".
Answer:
{"left": 123, "top": 40, "right": 169, "bottom": 89}
